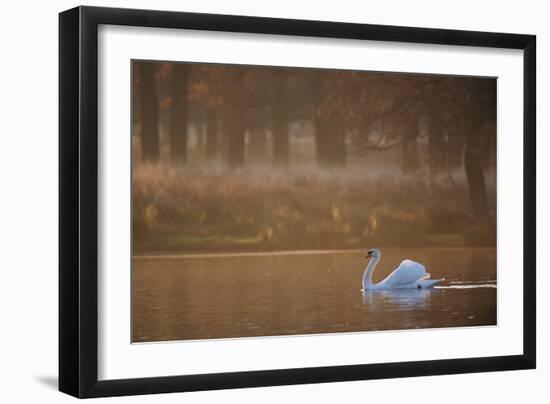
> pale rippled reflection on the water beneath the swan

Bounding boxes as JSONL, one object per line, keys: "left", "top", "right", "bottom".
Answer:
{"left": 363, "top": 288, "right": 440, "bottom": 310}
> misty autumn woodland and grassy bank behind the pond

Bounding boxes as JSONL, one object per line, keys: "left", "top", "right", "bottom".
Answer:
{"left": 132, "top": 61, "right": 496, "bottom": 255}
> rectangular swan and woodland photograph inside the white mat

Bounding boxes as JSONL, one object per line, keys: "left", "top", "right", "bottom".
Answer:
{"left": 130, "top": 60, "right": 497, "bottom": 343}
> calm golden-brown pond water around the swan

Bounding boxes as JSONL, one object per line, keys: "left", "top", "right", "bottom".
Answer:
{"left": 132, "top": 248, "right": 497, "bottom": 342}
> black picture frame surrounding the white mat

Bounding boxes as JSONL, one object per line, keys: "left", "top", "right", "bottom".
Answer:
{"left": 59, "top": 7, "right": 536, "bottom": 398}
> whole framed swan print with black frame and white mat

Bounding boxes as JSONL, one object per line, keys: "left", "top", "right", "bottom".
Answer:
{"left": 59, "top": 7, "right": 536, "bottom": 398}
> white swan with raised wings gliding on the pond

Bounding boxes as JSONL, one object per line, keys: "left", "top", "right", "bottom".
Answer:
{"left": 363, "top": 249, "right": 443, "bottom": 290}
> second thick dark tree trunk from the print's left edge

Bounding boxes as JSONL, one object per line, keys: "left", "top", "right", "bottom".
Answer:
{"left": 170, "top": 64, "right": 189, "bottom": 164}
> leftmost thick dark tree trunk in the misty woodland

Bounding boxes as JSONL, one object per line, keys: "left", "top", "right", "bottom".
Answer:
{"left": 139, "top": 62, "right": 159, "bottom": 162}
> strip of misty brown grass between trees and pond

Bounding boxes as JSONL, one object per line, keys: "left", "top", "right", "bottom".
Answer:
{"left": 133, "top": 164, "right": 496, "bottom": 254}
